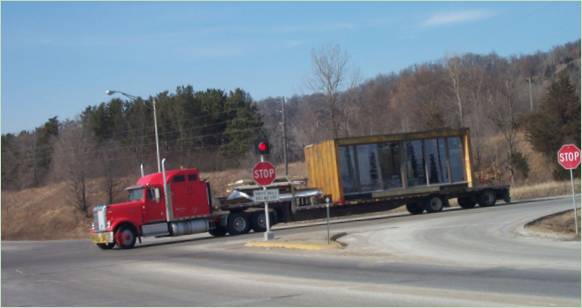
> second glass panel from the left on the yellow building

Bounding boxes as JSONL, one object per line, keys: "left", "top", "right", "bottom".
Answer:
{"left": 356, "top": 144, "right": 382, "bottom": 192}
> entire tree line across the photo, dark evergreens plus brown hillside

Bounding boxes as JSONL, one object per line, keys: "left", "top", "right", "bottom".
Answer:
{"left": 2, "top": 41, "right": 580, "bottom": 215}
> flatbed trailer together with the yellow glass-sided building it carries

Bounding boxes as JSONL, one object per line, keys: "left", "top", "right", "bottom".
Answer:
{"left": 226, "top": 128, "right": 511, "bottom": 222}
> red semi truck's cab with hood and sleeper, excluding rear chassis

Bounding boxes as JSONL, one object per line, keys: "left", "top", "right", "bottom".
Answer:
{"left": 92, "top": 168, "right": 211, "bottom": 249}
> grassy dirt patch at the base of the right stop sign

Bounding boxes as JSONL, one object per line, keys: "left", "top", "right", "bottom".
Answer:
{"left": 525, "top": 210, "right": 580, "bottom": 241}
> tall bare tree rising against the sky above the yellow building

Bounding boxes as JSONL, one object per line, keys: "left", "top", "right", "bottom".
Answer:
{"left": 308, "top": 45, "right": 348, "bottom": 138}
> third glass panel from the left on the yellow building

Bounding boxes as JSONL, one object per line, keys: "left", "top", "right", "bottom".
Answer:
{"left": 378, "top": 143, "right": 402, "bottom": 189}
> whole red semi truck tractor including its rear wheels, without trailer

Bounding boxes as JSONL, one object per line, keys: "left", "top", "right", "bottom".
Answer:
{"left": 92, "top": 160, "right": 292, "bottom": 249}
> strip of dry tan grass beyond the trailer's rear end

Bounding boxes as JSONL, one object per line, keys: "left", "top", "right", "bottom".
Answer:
{"left": 511, "top": 179, "right": 580, "bottom": 200}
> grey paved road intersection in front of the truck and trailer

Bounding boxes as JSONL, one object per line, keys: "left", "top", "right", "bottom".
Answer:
{"left": 1, "top": 198, "right": 580, "bottom": 306}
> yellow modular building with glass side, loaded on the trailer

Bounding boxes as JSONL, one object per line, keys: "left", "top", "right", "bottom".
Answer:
{"left": 304, "top": 128, "right": 474, "bottom": 204}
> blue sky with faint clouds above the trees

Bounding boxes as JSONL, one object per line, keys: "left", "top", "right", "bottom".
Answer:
{"left": 1, "top": 1, "right": 581, "bottom": 134}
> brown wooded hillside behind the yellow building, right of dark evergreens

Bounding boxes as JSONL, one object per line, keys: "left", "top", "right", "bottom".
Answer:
{"left": 259, "top": 40, "right": 580, "bottom": 184}
